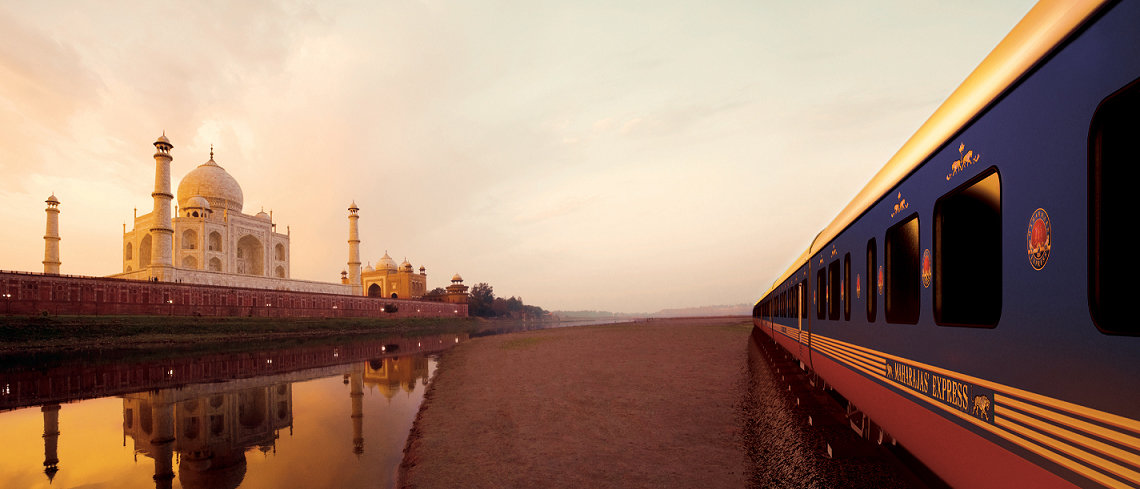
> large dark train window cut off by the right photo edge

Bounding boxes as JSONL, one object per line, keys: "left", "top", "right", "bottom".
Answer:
{"left": 1089, "top": 79, "right": 1140, "bottom": 335}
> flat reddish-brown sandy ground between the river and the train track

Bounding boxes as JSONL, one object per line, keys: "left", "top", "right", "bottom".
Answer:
{"left": 400, "top": 318, "right": 751, "bottom": 489}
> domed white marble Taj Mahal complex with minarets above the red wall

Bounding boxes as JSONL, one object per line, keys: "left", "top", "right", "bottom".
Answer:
{"left": 88, "top": 133, "right": 467, "bottom": 302}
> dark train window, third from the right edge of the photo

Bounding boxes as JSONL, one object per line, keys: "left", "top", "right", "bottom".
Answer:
{"left": 884, "top": 213, "right": 920, "bottom": 324}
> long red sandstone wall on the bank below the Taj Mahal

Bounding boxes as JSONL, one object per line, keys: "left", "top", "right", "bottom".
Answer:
{"left": 0, "top": 271, "right": 467, "bottom": 318}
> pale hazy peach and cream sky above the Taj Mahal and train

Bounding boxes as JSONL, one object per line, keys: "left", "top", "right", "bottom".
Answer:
{"left": 0, "top": 0, "right": 1032, "bottom": 312}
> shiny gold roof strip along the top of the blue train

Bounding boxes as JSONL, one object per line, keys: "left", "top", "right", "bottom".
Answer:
{"left": 764, "top": 0, "right": 1110, "bottom": 296}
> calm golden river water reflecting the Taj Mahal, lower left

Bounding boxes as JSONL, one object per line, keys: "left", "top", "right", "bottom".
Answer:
{"left": 0, "top": 334, "right": 467, "bottom": 488}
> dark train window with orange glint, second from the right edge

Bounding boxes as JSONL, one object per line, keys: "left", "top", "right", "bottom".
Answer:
{"left": 934, "top": 168, "right": 1001, "bottom": 327}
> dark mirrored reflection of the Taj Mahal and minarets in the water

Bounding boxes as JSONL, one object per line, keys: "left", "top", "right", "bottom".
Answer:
{"left": 100, "top": 354, "right": 430, "bottom": 488}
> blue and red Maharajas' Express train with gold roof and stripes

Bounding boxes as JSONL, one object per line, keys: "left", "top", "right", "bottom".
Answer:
{"left": 752, "top": 0, "right": 1140, "bottom": 488}
